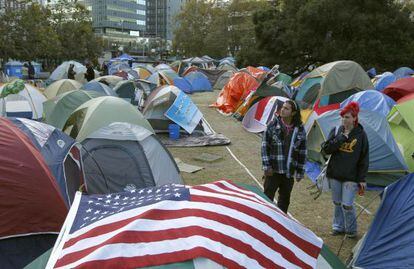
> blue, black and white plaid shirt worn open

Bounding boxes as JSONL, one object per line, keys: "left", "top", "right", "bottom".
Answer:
{"left": 262, "top": 117, "right": 307, "bottom": 179}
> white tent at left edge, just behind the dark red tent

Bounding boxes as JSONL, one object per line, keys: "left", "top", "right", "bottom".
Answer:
{"left": 0, "top": 84, "right": 47, "bottom": 120}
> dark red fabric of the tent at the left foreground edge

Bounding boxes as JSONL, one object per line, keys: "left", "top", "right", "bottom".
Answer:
{"left": 0, "top": 118, "right": 68, "bottom": 238}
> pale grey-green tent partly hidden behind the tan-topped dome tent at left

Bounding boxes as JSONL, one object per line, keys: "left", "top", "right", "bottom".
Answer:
{"left": 43, "top": 90, "right": 103, "bottom": 129}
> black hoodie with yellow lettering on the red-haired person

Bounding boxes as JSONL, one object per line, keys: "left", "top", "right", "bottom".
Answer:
{"left": 322, "top": 124, "right": 369, "bottom": 183}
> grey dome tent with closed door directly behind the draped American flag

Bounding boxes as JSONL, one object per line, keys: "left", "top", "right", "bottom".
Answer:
{"left": 82, "top": 122, "right": 182, "bottom": 194}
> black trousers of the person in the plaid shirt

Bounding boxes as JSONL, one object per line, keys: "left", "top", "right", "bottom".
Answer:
{"left": 263, "top": 173, "right": 295, "bottom": 213}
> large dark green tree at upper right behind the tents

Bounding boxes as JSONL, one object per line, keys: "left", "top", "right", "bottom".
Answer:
{"left": 254, "top": 0, "right": 414, "bottom": 72}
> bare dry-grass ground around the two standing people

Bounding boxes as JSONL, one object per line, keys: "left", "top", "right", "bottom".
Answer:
{"left": 169, "top": 91, "right": 380, "bottom": 262}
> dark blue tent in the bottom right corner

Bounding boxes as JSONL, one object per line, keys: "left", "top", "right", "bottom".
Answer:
{"left": 353, "top": 174, "right": 414, "bottom": 269}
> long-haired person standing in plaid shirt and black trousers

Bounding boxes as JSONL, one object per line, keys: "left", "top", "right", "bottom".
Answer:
{"left": 262, "top": 100, "right": 306, "bottom": 213}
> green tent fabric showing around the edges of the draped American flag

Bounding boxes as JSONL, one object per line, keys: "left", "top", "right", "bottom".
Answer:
{"left": 24, "top": 183, "right": 346, "bottom": 269}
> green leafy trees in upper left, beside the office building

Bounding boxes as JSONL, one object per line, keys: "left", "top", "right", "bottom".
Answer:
{"left": 0, "top": 0, "right": 102, "bottom": 60}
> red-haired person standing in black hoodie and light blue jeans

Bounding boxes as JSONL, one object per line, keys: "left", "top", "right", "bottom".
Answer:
{"left": 322, "top": 102, "right": 369, "bottom": 238}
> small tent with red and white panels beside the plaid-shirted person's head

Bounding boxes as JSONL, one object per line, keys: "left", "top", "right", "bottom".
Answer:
{"left": 242, "top": 96, "right": 288, "bottom": 133}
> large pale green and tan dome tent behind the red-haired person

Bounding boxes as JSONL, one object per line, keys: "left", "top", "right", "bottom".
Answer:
{"left": 295, "top": 61, "right": 374, "bottom": 108}
